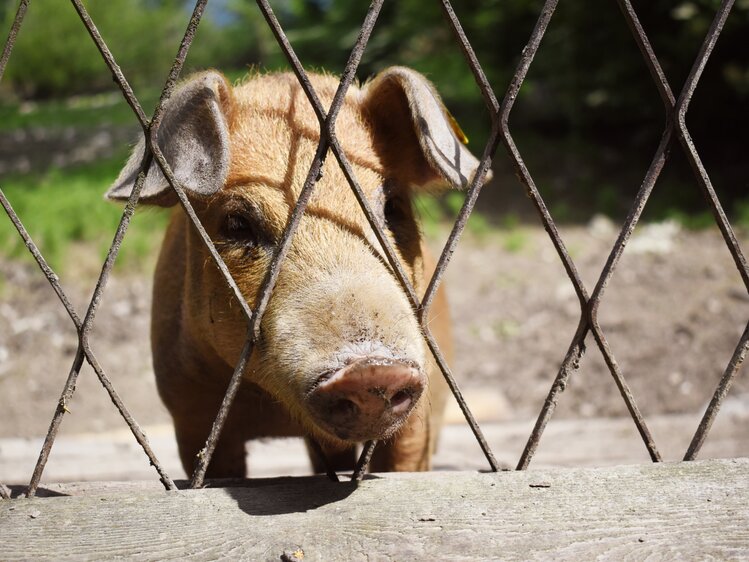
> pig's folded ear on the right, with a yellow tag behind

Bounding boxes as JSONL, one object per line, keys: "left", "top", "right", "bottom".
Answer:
{"left": 362, "top": 66, "right": 491, "bottom": 188}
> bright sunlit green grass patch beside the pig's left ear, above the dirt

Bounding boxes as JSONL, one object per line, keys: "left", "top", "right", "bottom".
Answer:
{"left": 0, "top": 153, "right": 166, "bottom": 272}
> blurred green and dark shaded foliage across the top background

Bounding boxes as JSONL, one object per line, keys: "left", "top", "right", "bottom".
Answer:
{"left": 0, "top": 0, "right": 749, "bottom": 270}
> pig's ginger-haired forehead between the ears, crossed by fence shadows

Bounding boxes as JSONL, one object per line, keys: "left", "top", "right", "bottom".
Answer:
{"left": 227, "top": 74, "right": 384, "bottom": 215}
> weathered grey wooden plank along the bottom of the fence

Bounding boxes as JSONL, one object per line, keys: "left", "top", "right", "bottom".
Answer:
{"left": 0, "top": 459, "right": 749, "bottom": 561}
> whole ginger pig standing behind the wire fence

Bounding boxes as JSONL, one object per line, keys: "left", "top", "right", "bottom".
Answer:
{"left": 107, "top": 67, "right": 488, "bottom": 477}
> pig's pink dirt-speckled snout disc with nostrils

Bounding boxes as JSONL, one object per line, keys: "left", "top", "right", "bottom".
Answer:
{"left": 308, "top": 357, "right": 425, "bottom": 441}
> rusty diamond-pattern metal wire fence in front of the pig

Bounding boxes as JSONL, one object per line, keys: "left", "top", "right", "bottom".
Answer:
{"left": 0, "top": 0, "right": 749, "bottom": 499}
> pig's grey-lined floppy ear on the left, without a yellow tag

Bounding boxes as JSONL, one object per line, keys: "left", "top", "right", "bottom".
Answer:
{"left": 107, "top": 72, "right": 232, "bottom": 207}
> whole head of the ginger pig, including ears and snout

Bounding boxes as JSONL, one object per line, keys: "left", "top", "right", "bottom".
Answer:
{"left": 108, "top": 68, "right": 488, "bottom": 441}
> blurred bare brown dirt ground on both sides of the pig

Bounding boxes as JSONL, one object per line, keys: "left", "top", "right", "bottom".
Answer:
{"left": 0, "top": 217, "right": 749, "bottom": 444}
